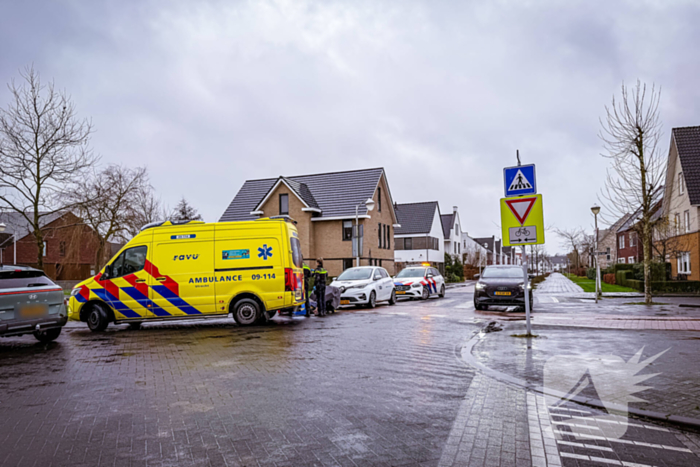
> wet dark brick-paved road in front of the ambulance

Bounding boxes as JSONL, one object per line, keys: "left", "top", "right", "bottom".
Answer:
{"left": 0, "top": 287, "right": 696, "bottom": 467}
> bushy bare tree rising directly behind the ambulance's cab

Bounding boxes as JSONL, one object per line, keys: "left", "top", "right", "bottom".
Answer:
{"left": 69, "top": 165, "right": 151, "bottom": 271}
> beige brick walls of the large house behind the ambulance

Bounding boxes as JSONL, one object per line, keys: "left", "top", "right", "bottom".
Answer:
{"left": 254, "top": 176, "right": 395, "bottom": 277}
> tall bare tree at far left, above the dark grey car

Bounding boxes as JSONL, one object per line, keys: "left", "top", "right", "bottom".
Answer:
{"left": 0, "top": 68, "right": 96, "bottom": 269}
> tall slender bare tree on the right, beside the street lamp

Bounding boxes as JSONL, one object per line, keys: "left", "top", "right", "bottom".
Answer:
{"left": 600, "top": 81, "right": 665, "bottom": 304}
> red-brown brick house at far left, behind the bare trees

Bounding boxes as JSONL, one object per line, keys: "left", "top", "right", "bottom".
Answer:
{"left": 0, "top": 212, "right": 98, "bottom": 281}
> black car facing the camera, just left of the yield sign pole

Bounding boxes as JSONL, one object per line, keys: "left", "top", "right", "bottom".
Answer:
{"left": 474, "top": 266, "right": 533, "bottom": 310}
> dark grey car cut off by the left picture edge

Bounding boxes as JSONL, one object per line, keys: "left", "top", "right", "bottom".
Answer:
{"left": 0, "top": 266, "right": 68, "bottom": 342}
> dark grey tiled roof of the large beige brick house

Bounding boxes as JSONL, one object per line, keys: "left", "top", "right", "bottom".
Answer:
{"left": 219, "top": 168, "right": 391, "bottom": 222}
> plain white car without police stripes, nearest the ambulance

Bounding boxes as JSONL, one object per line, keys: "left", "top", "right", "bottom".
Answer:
{"left": 331, "top": 266, "right": 396, "bottom": 308}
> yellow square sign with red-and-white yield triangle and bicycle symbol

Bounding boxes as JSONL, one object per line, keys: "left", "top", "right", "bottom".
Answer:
{"left": 501, "top": 195, "right": 544, "bottom": 246}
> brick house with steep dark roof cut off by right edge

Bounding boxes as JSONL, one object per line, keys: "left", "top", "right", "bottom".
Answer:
{"left": 655, "top": 126, "right": 700, "bottom": 280}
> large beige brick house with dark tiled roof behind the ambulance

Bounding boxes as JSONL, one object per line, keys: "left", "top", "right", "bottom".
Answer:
{"left": 219, "top": 168, "right": 399, "bottom": 276}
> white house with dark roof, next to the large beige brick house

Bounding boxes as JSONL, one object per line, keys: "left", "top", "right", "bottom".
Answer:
{"left": 394, "top": 201, "right": 445, "bottom": 274}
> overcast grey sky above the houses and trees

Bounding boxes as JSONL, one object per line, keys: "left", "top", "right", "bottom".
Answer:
{"left": 0, "top": 0, "right": 700, "bottom": 251}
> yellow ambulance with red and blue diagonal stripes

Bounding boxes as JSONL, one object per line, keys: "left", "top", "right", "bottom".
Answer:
{"left": 68, "top": 216, "right": 304, "bottom": 331}
